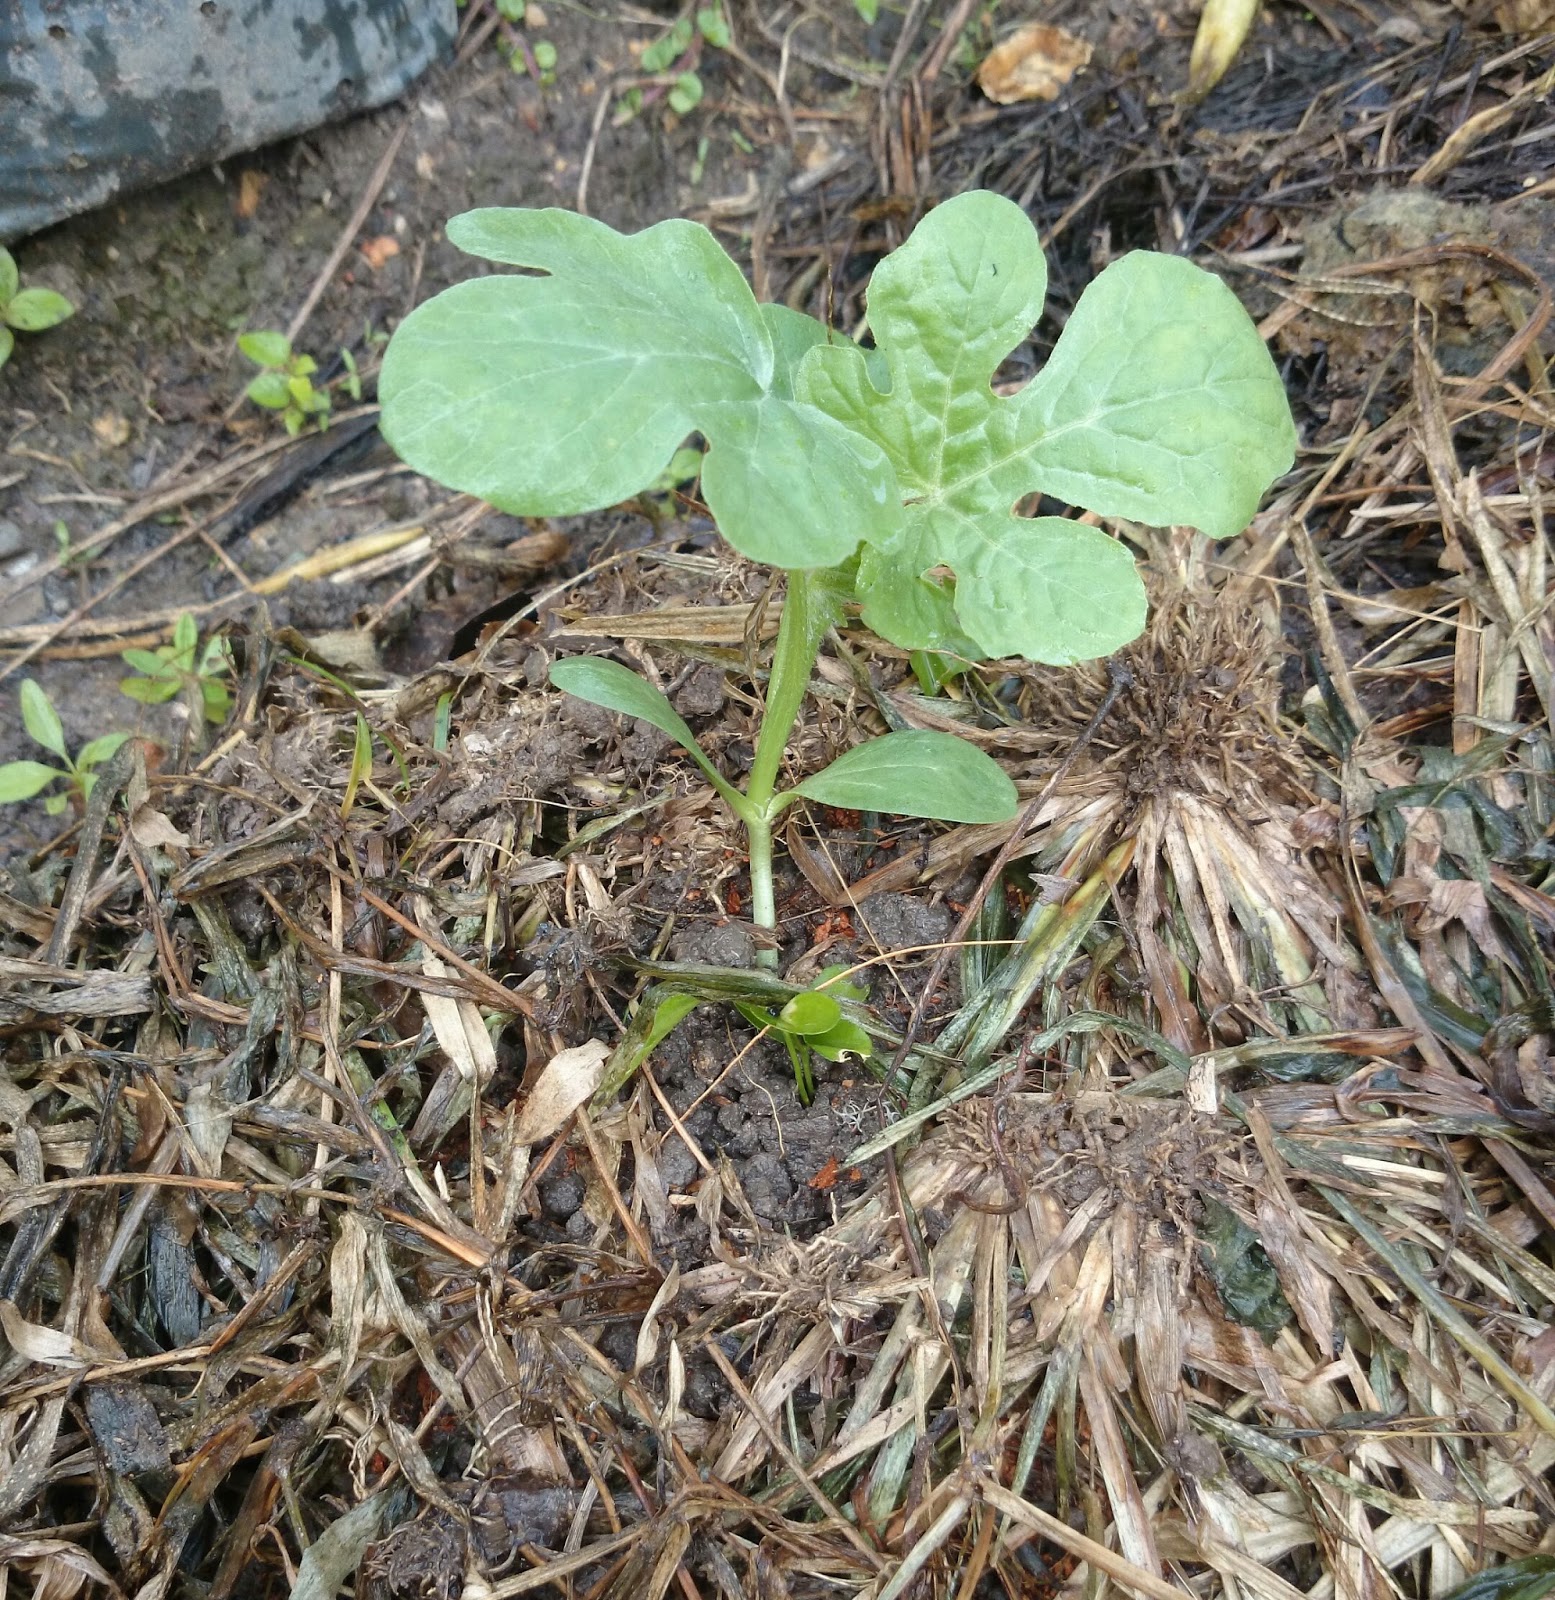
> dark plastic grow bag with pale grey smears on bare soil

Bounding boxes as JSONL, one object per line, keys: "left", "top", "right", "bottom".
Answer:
{"left": 0, "top": 0, "right": 456, "bottom": 242}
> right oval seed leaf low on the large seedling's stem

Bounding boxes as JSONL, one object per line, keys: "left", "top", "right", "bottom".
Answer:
{"left": 795, "top": 731, "right": 1019, "bottom": 822}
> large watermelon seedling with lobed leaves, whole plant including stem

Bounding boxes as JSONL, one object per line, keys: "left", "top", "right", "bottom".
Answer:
{"left": 379, "top": 192, "right": 1294, "bottom": 960}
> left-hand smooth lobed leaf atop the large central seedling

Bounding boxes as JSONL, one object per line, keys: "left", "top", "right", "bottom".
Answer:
{"left": 379, "top": 210, "right": 901, "bottom": 568}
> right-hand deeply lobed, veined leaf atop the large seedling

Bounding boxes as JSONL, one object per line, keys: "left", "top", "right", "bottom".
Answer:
{"left": 798, "top": 192, "right": 1294, "bottom": 664}
